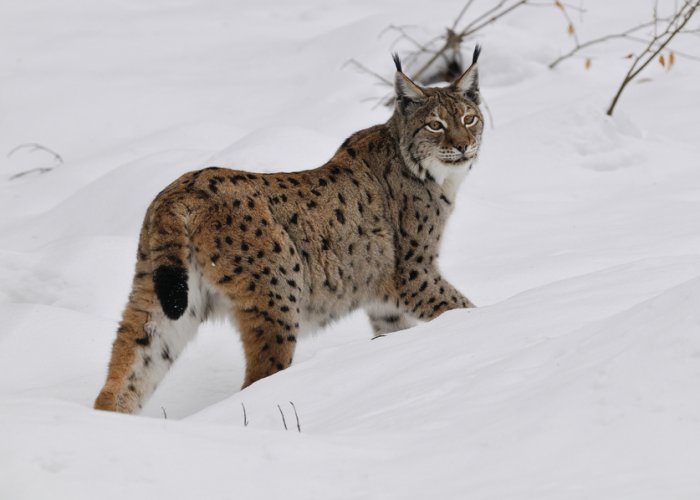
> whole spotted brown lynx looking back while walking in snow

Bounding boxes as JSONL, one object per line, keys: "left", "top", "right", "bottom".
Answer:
{"left": 95, "top": 46, "right": 484, "bottom": 413}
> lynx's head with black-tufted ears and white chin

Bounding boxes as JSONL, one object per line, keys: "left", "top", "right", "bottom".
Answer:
{"left": 391, "top": 45, "right": 484, "bottom": 184}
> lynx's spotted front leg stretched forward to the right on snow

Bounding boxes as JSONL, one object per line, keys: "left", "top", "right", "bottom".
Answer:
{"left": 396, "top": 269, "right": 476, "bottom": 321}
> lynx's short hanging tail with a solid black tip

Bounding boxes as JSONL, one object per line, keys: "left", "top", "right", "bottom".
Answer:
{"left": 148, "top": 200, "right": 190, "bottom": 320}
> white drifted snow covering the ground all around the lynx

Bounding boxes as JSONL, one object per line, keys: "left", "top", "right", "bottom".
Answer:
{"left": 0, "top": 0, "right": 700, "bottom": 500}
